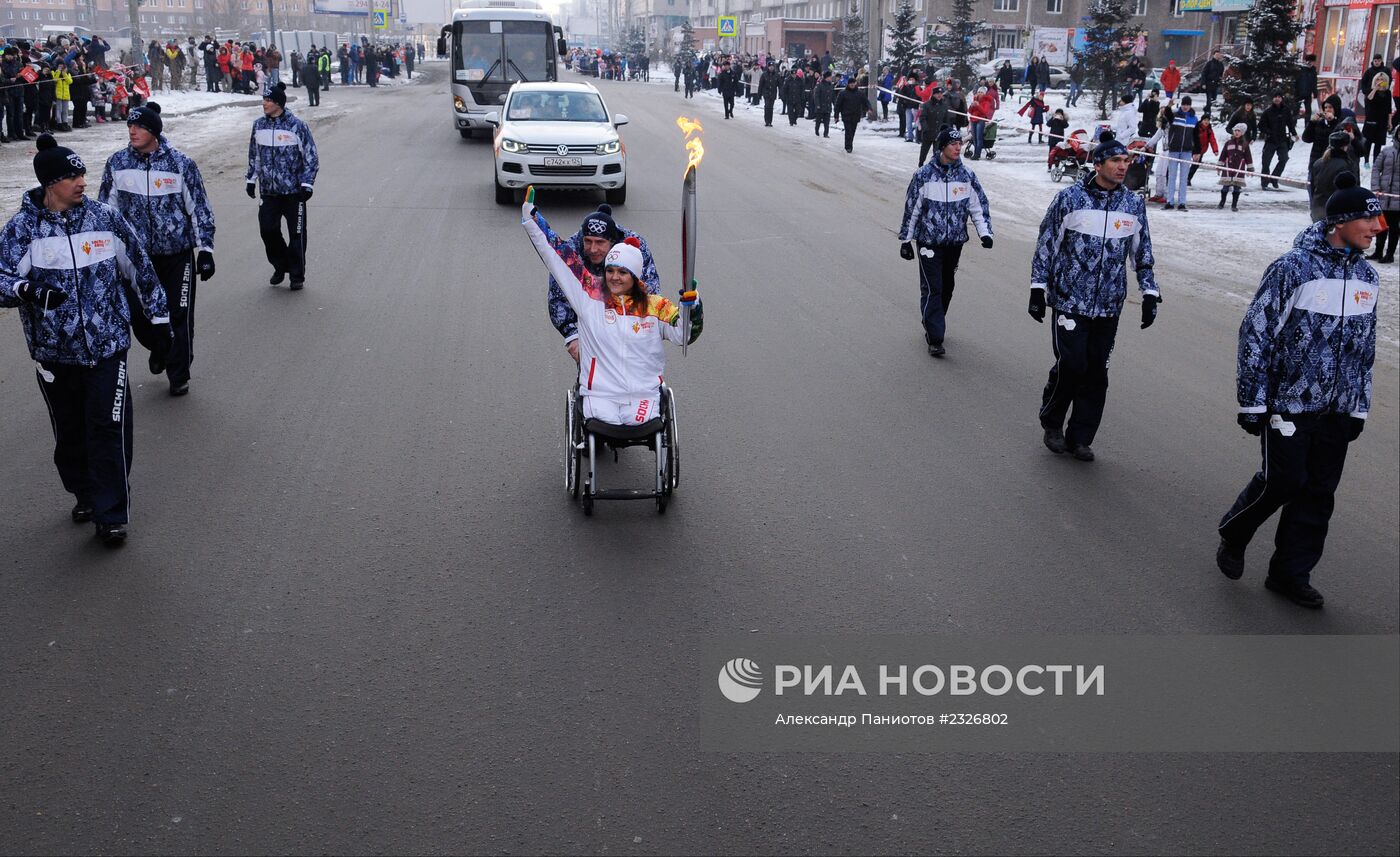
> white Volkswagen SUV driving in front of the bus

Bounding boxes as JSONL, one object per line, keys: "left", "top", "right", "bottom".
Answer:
{"left": 486, "top": 81, "right": 627, "bottom": 206}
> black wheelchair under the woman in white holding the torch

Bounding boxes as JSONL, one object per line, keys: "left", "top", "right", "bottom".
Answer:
{"left": 564, "top": 384, "right": 680, "bottom": 515}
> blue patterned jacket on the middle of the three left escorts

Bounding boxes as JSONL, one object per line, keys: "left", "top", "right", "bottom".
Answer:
{"left": 97, "top": 137, "right": 214, "bottom": 256}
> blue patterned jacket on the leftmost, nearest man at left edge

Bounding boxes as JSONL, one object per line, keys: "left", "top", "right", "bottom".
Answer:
{"left": 0, "top": 188, "right": 169, "bottom": 365}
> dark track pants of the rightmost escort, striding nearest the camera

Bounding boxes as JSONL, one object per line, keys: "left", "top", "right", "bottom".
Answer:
{"left": 1219, "top": 413, "right": 1351, "bottom": 583}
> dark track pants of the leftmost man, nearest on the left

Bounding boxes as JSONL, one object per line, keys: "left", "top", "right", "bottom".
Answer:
{"left": 35, "top": 351, "right": 132, "bottom": 524}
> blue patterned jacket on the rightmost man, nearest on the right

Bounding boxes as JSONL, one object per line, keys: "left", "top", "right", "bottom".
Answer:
{"left": 1236, "top": 223, "right": 1380, "bottom": 419}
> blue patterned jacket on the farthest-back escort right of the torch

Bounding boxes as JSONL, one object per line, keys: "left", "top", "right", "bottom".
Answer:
{"left": 899, "top": 155, "right": 991, "bottom": 246}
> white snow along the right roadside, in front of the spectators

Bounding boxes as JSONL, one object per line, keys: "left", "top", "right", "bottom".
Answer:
{"left": 627, "top": 70, "right": 1400, "bottom": 365}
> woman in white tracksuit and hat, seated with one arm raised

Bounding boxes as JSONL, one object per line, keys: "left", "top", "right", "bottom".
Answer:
{"left": 521, "top": 188, "right": 704, "bottom": 426}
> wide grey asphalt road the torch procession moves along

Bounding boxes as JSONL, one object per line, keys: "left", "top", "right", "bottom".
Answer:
{"left": 0, "top": 68, "right": 1400, "bottom": 854}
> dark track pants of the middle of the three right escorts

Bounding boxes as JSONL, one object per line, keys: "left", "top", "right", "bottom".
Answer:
{"left": 1040, "top": 311, "right": 1119, "bottom": 448}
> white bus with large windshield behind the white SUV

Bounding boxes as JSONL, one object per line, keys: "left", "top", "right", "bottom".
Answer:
{"left": 442, "top": 0, "right": 568, "bottom": 137}
